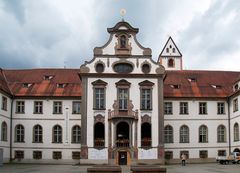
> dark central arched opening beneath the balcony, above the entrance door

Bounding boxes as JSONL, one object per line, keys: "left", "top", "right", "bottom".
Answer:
{"left": 116, "top": 122, "right": 129, "bottom": 147}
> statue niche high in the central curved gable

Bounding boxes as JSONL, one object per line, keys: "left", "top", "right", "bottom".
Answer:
{"left": 115, "top": 34, "right": 132, "bottom": 56}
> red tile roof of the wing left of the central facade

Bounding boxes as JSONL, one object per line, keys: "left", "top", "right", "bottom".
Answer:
{"left": 4, "top": 69, "right": 82, "bottom": 97}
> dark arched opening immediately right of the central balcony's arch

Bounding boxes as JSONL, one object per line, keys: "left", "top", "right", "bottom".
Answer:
{"left": 141, "top": 122, "right": 152, "bottom": 147}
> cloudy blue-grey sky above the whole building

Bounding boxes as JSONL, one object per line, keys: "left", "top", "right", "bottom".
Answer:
{"left": 0, "top": 0, "right": 240, "bottom": 71}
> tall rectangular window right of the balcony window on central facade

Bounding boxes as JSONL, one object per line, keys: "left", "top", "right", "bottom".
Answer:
{"left": 141, "top": 89, "right": 152, "bottom": 110}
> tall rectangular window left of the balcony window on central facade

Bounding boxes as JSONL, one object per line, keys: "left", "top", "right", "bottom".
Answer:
{"left": 94, "top": 88, "right": 105, "bottom": 110}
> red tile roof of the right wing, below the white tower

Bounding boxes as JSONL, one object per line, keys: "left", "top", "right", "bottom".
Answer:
{"left": 164, "top": 70, "right": 240, "bottom": 98}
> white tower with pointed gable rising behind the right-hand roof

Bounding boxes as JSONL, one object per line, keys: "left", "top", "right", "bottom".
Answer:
{"left": 158, "top": 37, "right": 183, "bottom": 70}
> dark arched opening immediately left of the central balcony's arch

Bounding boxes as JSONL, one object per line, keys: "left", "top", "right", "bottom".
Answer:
{"left": 94, "top": 122, "right": 105, "bottom": 147}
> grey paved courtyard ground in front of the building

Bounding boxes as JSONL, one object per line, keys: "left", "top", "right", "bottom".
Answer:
{"left": 0, "top": 163, "right": 240, "bottom": 173}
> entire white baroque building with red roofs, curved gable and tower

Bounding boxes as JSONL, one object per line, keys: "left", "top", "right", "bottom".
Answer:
{"left": 0, "top": 21, "right": 240, "bottom": 165}
